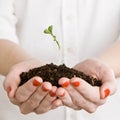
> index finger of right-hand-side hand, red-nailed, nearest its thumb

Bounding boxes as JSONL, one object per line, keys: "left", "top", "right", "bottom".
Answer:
{"left": 70, "top": 77, "right": 105, "bottom": 104}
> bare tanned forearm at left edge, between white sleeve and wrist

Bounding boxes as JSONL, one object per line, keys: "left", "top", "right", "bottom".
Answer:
{"left": 0, "top": 40, "right": 30, "bottom": 75}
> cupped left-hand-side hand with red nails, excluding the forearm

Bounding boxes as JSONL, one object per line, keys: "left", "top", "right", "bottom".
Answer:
{"left": 4, "top": 59, "right": 62, "bottom": 114}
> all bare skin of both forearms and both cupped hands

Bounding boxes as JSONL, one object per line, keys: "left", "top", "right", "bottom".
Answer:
{"left": 0, "top": 38, "right": 120, "bottom": 114}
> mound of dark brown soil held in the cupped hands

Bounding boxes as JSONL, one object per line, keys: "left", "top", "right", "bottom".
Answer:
{"left": 19, "top": 63, "right": 102, "bottom": 87}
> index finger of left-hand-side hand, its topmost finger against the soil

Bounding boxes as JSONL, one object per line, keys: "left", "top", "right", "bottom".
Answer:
{"left": 15, "top": 77, "right": 42, "bottom": 102}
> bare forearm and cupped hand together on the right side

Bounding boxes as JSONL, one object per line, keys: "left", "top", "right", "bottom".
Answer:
{"left": 56, "top": 40, "right": 120, "bottom": 113}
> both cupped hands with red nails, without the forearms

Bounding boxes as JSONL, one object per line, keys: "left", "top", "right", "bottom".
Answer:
{"left": 4, "top": 59, "right": 116, "bottom": 114}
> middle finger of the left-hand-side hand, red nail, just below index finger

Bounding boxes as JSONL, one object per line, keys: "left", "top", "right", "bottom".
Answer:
{"left": 20, "top": 82, "right": 52, "bottom": 114}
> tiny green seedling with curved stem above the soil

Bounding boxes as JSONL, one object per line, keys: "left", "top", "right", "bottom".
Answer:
{"left": 44, "top": 25, "right": 60, "bottom": 50}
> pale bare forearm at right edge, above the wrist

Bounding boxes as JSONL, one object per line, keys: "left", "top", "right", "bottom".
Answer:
{"left": 99, "top": 40, "right": 120, "bottom": 77}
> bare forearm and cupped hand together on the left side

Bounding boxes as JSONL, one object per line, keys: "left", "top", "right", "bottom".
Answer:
{"left": 0, "top": 40, "right": 62, "bottom": 114}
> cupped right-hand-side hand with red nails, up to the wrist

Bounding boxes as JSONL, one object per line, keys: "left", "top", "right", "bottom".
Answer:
{"left": 56, "top": 58, "right": 116, "bottom": 113}
